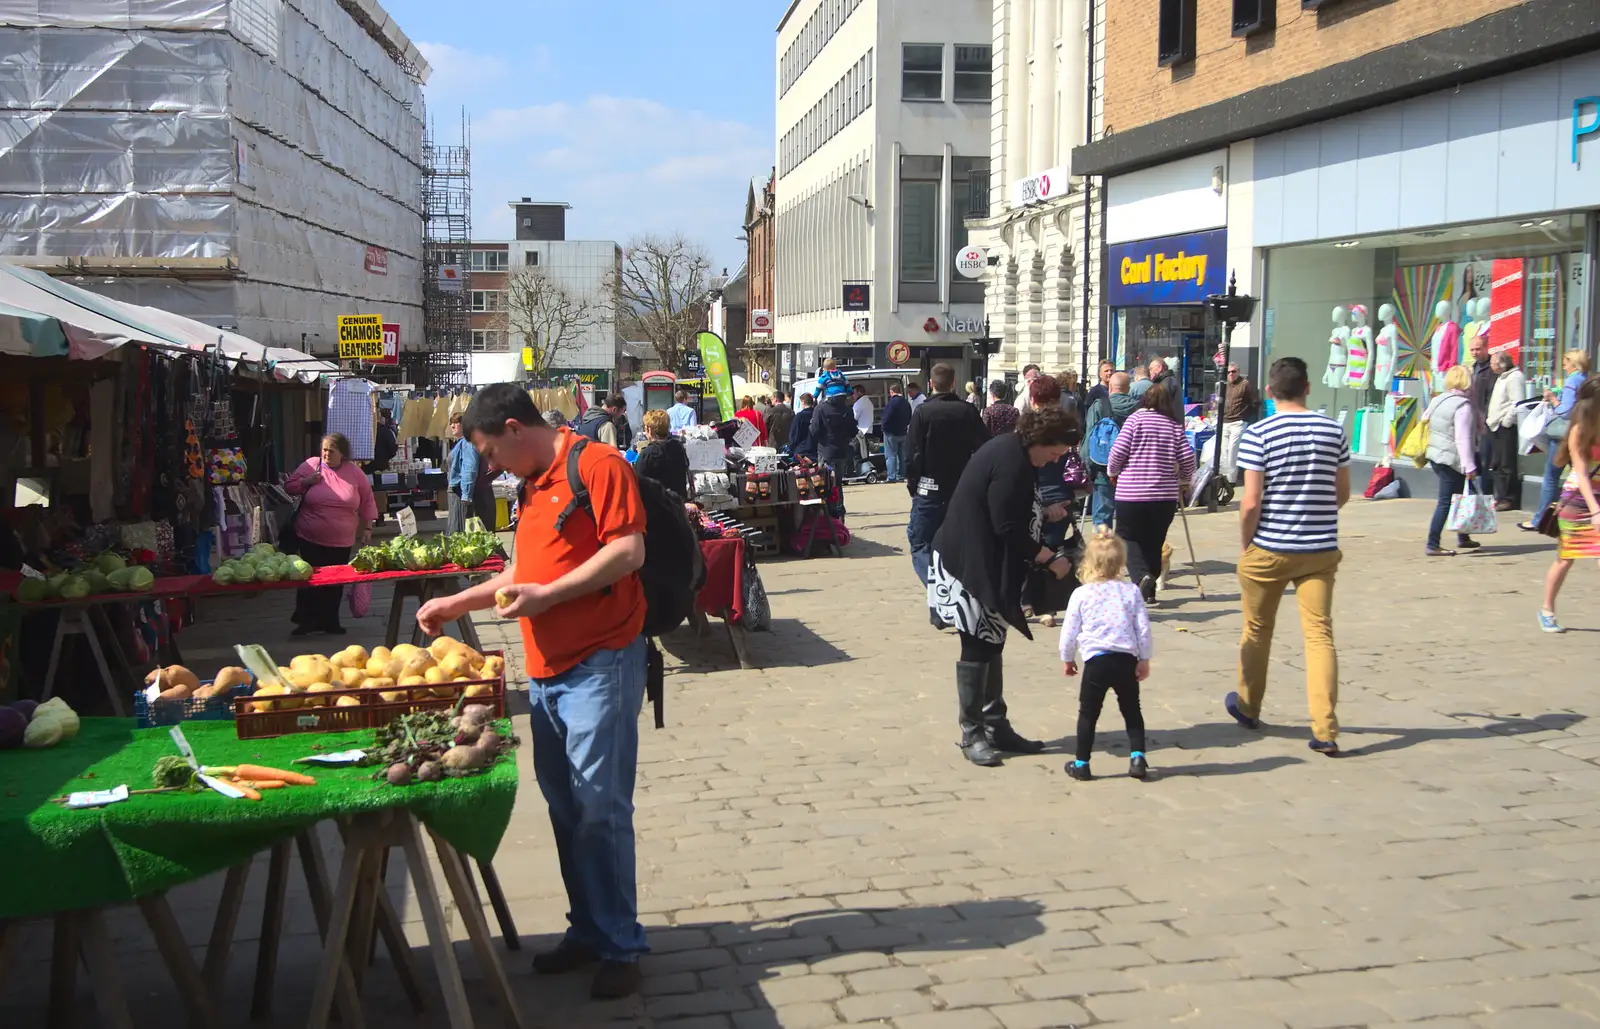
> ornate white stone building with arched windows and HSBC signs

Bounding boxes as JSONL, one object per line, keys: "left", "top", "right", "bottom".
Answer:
{"left": 968, "top": 0, "right": 1106, "bottom": 378}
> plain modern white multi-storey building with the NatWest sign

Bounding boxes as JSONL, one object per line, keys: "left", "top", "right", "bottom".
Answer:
{"left": 774, "top": 0, "right": 992, "bottom": 379}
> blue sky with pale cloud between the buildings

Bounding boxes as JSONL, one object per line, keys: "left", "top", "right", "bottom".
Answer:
{"left": 382, "top": 0, "right": 786, "bottom": 270}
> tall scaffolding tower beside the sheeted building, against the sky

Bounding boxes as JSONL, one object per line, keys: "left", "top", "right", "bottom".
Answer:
{"left": 402, "top": 110, "right": 472, "bottom": 387}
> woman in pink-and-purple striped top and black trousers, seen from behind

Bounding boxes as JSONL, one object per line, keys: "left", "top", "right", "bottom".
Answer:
{"left": 1109, "top": 384, "right": 1195, "bottom": 603}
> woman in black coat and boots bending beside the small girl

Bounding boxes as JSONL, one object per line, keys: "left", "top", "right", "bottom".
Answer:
{"left": 928, "top": 406, "right": 1077, "bottom": 767}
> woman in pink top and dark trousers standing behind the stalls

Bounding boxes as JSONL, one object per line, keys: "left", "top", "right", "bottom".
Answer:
{"left": 283, "top": 432, "right": 378, "bottom": 635}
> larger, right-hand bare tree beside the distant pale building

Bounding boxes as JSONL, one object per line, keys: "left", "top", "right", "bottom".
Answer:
{"left": 618, "top": 234, "right": 710, "bottom": 371}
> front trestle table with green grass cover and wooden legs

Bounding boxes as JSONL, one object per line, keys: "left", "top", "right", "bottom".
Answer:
{"left": 0, "top": 719, "right": 522, "bottom": 1029}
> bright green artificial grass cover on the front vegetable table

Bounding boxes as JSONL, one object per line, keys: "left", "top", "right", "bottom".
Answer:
{"left": 0, "top": 719, "right": 517, "bottom": 919}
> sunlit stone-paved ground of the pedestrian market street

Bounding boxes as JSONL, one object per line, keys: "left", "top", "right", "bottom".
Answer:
{"left": 0, "top": 485, "right": 1600, "bottom": 1029}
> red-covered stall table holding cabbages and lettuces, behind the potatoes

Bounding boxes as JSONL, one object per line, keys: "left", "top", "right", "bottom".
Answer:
{"left": 0, "top": 557, "right": 506, "bottom": 717}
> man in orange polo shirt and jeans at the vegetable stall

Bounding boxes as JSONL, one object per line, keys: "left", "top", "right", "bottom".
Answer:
{"left": 416, "top": 382, "right": 648, "bottom": 999}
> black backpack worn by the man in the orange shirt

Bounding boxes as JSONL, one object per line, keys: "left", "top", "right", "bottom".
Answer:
{"left": 555, "top": 437, "right": 706, "bottom": 728}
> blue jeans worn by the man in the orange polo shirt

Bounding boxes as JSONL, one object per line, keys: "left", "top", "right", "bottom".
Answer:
{"left": 528, "top": 637, "right": 650, "bottom": 962}
